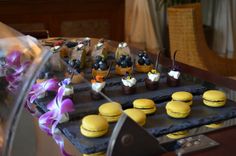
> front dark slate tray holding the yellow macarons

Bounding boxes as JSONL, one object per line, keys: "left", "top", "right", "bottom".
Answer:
{"left": 59, "top": 96, "right": 236, "bottom": 154}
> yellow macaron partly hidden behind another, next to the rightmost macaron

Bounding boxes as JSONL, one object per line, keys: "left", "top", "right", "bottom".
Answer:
{"left": 171, "top": 91, "right": 193, "bottom": 105}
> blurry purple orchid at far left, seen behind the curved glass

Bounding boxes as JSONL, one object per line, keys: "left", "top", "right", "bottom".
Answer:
{"left": 5, "top": 51, "right": 30, "bottom": 92}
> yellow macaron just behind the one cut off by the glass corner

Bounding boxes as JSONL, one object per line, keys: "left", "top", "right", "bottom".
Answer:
{"left": 133, "top": 99, "right": 156, "bottom": 114}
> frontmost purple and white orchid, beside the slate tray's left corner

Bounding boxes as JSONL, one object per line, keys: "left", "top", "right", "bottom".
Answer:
{"left": 39, "top": 86, "right": 74, "bottom": 156}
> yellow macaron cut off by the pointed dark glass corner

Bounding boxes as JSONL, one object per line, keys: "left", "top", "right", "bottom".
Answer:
{"left": 124, "top": 108, "right": 146, "bottom": 126}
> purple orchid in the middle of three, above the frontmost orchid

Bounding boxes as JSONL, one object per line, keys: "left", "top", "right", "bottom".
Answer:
{"left": 26, "top": 79, "right": 59, "bottom": 115}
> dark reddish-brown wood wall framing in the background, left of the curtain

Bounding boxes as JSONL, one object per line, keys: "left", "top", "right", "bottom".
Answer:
{"left": 0, "top": 0, "right": 124, "bottom": 41}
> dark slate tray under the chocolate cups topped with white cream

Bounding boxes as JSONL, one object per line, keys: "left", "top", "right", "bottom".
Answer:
{"left": 35, "top": 71, "right": 207, "bottom": 120}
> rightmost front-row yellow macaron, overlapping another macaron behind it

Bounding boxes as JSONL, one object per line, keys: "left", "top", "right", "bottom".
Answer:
{"left": 166, "top": 101, "right": 191, "bottom": 118}
